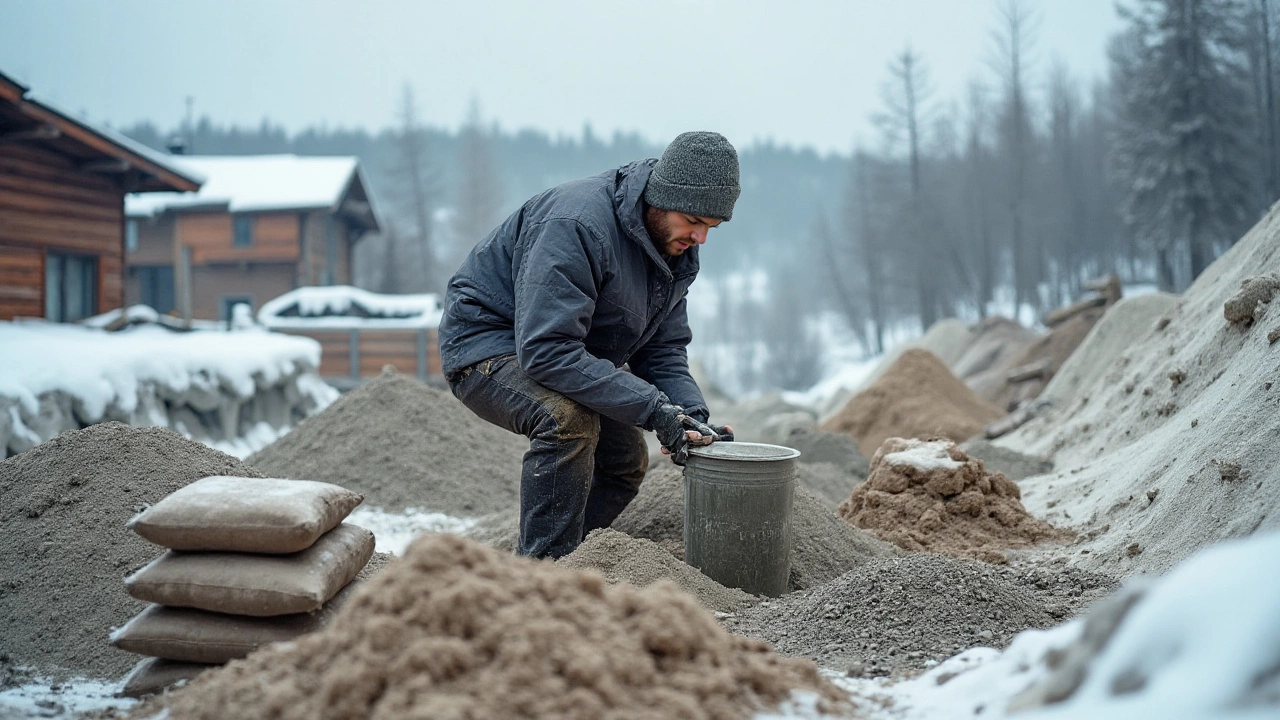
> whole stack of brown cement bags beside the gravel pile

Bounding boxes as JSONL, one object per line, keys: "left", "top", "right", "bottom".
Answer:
{"left": 111, "top": 477, "right": 374, "bottom": 697}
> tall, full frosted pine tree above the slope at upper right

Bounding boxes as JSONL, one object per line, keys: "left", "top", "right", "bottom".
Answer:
{"left": 1112, "top": 0, "right": 1256, "bottom": 290}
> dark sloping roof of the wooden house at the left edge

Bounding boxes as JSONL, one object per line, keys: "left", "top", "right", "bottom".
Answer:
{"left": 0, "top": 73, "right": 204, "bottom": 192}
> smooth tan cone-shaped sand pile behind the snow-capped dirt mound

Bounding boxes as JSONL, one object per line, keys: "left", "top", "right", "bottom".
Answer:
{"left": 822, "top": 350, "right": 1004, "bottom": 456}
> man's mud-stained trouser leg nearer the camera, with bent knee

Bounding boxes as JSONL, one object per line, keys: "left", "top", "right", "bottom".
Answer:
{"left": 449, "top": 355, "right": 600, "bottom": 557}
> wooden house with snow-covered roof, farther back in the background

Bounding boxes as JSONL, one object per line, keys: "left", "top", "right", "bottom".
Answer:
{"left": 125, "top": 155, "right": 379, "bottom": 320}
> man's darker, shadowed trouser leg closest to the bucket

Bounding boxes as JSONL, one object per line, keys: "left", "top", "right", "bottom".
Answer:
{"left": 582, "top": 415, "right": 649, "bottom": 537}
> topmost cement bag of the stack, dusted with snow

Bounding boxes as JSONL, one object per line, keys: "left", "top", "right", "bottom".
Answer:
{"left": 128, "top": 475, "right": 365, "bottom": 553}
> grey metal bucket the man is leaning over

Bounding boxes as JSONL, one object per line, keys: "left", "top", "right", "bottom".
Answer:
{"left": 685, "top": 442, "right": 800, "bottom": 597}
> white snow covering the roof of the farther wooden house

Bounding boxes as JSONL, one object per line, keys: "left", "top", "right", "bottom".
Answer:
{"left": 124, "top": 155, "right": 358, "bottom": 218}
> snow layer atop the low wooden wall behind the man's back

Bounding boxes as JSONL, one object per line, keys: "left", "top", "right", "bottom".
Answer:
{"left": 257, "top": 284, "right": 443, "bottom": 328}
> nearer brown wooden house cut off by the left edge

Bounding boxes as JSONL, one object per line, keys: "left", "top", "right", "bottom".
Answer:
{"left": 0, "top": 73, "right": 200, "bottom": 322}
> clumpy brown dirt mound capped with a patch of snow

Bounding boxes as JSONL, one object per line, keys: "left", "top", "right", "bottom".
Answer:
{"left": 838, "top": 438, "right": 1062, "bottom": 562}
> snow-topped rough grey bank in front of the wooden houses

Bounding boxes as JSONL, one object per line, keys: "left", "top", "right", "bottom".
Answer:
{"left": 0, "top": 315, "right": 338, "bottom": 457}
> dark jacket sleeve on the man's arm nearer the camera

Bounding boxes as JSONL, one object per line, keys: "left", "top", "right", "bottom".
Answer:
{"left": 515, "top": 219, "right": 658, "bottom": 425}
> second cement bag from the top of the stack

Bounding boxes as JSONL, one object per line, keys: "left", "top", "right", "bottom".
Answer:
{"left": 124, "top": 524, "right": 374, "bottom": 618}
